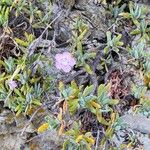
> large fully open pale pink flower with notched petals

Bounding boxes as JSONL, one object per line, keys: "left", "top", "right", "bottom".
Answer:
{"left": 55, "top": 52, "right": 76, "bottom": 73}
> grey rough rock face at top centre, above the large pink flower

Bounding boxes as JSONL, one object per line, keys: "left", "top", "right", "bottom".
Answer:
{"left": 52, "top": 0, "right": 107, "bottom": 44}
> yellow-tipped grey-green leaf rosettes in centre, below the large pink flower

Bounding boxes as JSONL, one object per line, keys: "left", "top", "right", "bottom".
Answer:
{"left": 59, "top": 82, "right": 118, "bottom": 125}
